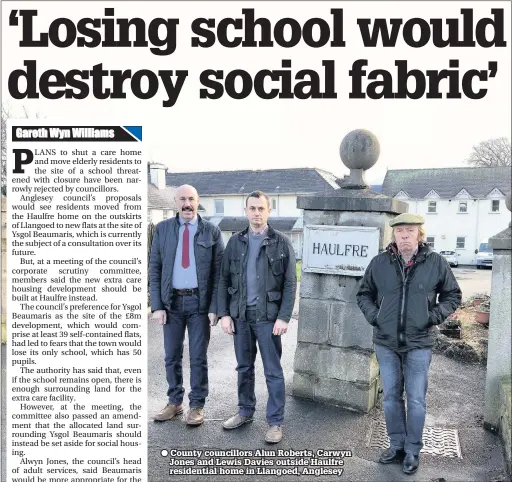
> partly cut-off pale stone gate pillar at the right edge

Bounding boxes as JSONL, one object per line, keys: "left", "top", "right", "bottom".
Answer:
{"left": 484, "top": 193, "right": 512, "bottom": 432}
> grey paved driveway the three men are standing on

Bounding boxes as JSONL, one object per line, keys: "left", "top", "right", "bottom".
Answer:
{"left": 148, "top": 304, "right": 505, "bottom": 482}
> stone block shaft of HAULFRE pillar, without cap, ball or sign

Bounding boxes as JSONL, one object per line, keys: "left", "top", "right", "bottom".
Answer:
{"left": 293, "top": 211, "right": 394, "bottom": 412}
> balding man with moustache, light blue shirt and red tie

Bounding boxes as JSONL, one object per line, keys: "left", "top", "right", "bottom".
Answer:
{"left": 149, "top": 184, "right": 224, "bottom": 425}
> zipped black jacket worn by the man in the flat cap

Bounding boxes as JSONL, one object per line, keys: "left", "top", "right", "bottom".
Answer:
{"left": 356, "top": 244, "right": 462, "bottom": 351}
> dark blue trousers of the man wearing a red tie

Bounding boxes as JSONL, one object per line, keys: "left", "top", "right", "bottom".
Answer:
{"left": 163, "top": 295, "right": 210, "bottom": 408}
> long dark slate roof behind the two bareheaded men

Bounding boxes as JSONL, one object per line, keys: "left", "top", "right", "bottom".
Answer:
{"left": 166, "top": 168, "right": 339, "bottom": 196}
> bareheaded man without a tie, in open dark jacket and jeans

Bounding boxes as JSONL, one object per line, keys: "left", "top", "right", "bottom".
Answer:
{"left": 218, "top": 191, "right": 297, "bottom": 443}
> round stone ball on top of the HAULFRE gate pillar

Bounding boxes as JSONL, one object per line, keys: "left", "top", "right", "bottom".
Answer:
{"left": 340, "top": 129, "right": 380, "bottom": 171}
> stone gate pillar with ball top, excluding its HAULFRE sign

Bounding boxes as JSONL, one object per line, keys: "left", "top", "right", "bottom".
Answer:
{"left": 293, "top": 130, "right": 408, "bottom": 412}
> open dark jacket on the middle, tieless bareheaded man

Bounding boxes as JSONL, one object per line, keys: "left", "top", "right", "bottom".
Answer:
{"left": 218, "top": 225, "right": 297, "bottom": 321}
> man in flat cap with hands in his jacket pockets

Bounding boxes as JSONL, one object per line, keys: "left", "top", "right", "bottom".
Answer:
{"left": 357, "top": 213, "right": 462, "bottom": 474}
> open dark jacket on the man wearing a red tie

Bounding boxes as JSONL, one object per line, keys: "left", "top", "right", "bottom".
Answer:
{"left": 149, "top": 215, "right": 224, "bottom": 313}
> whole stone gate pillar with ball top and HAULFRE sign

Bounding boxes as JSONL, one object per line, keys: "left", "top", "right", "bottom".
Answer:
{"left": 293, "top": 129, "right": 408, "bottom": 412}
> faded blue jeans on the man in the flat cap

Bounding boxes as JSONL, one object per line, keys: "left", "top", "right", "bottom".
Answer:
{"left": 375, "top": 344, "right": 432, "bottom": 455}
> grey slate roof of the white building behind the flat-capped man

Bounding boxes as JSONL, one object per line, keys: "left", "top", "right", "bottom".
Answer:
{"left": 382, "top": 167, "right": 512, "bottom": 199}
